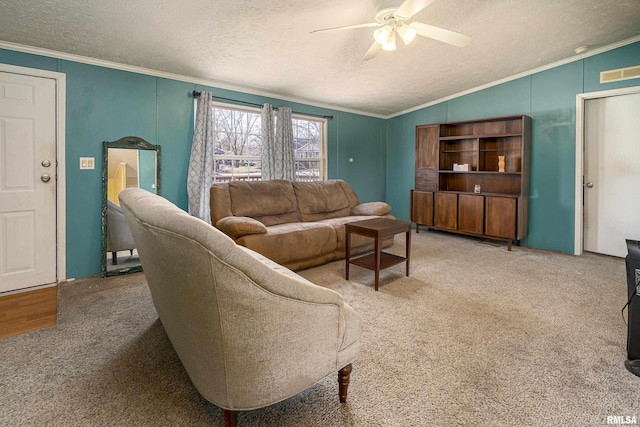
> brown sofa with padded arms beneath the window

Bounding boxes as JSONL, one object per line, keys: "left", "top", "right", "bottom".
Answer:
{"left": 210, "top": 180, "right": 393, "bottom": 270}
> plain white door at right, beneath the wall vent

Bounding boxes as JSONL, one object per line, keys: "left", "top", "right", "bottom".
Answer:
{"left": 583, "top": 93, "right": 640, "bottom": 257}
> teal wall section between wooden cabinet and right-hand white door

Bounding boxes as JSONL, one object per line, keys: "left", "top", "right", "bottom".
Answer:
{"left": 524, "top": 62, "right": 582, "bottom": 253}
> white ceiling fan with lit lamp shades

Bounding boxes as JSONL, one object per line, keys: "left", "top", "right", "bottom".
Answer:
{"left": 311, "top": 0, "right": 471, "bottom": 61}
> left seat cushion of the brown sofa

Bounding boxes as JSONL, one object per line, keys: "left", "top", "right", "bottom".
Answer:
{"left": 237, "top": 222, "right": 337, "bottom": 264}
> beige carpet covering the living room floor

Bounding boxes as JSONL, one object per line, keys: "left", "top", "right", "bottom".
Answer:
{"left": 0, "top": 232, "right": 640, "bottom": 426}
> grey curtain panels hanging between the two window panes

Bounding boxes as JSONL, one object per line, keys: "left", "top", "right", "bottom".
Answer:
{"left": 262, "top": 104, "right": 296, "bottom": 181}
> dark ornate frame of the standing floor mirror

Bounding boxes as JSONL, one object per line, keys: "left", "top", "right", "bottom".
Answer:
{"left": 100, "top": 136, "right": 162, "bottom": 277}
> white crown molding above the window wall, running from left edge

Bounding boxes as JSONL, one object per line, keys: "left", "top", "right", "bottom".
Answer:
{"left": 0, "top": 40, "right": 385, "bottom": 119}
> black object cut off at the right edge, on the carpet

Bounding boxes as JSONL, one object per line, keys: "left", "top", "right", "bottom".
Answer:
{"left": 623, "top": 239, "right": 640, "bottom": 377}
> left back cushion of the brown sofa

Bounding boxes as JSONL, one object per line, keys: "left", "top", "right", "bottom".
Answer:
{"left": 229, "top": 180, "right": 299, "bottom": 226}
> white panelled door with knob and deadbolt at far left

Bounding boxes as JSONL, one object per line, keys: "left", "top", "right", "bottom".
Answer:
{"left": 0, "top": 72, "right": 56, "bottom": 292}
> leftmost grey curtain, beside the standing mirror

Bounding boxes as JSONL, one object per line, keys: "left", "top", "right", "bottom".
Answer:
{"left": 187, "top": 91, "right": 214, "bottom": 223}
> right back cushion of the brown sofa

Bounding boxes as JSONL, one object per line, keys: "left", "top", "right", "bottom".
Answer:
{"left": 293, "top": 181, "right": 351, "bottom": 221}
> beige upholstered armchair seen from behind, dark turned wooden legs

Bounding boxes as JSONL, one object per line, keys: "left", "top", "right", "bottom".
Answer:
{"left": 120, "top": 188, "right": 360, "bottom": 425}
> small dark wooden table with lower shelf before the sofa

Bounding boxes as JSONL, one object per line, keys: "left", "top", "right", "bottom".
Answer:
{"left": 344, "top": 218, "right": 411, "bottom": 291}
